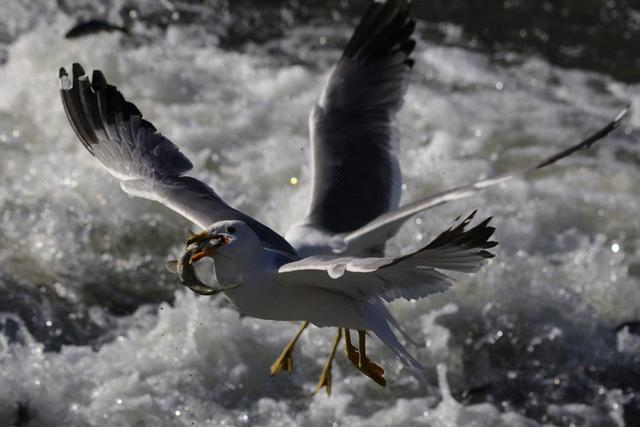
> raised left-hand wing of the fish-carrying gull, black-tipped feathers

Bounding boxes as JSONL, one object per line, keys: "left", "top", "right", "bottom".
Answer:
{"left": 60, "top": 64, "right": 295, "bottom": 254}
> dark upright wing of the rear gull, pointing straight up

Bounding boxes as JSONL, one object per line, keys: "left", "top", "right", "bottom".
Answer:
{"left": 305, "top": 0, "right": 415, "bottom": 233}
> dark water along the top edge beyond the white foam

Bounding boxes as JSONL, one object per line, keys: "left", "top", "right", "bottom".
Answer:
{"left": 6, "top": 0, "right": 640, "bottom": 82}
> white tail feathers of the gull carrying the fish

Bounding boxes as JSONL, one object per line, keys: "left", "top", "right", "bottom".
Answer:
{"left": 358, "top": 300, "right": 425, "bottom": 372}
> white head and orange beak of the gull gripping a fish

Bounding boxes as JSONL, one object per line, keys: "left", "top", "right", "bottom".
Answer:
{"left": 187, "top": 220, "right": 262, "bottom": 263}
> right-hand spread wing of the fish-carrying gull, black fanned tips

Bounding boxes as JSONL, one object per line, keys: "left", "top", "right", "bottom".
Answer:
{"left": 277, "top": 212, "right": 498, "bottom": 302}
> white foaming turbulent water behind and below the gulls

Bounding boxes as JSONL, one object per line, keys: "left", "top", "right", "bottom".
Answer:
{"left": 0, "top": 0, "right": 640, "bottom": 426}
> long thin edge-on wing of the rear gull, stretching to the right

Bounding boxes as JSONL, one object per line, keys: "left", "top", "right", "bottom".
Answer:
{"left": 330, "top": 106, "right": 630, "bottom": 253}
